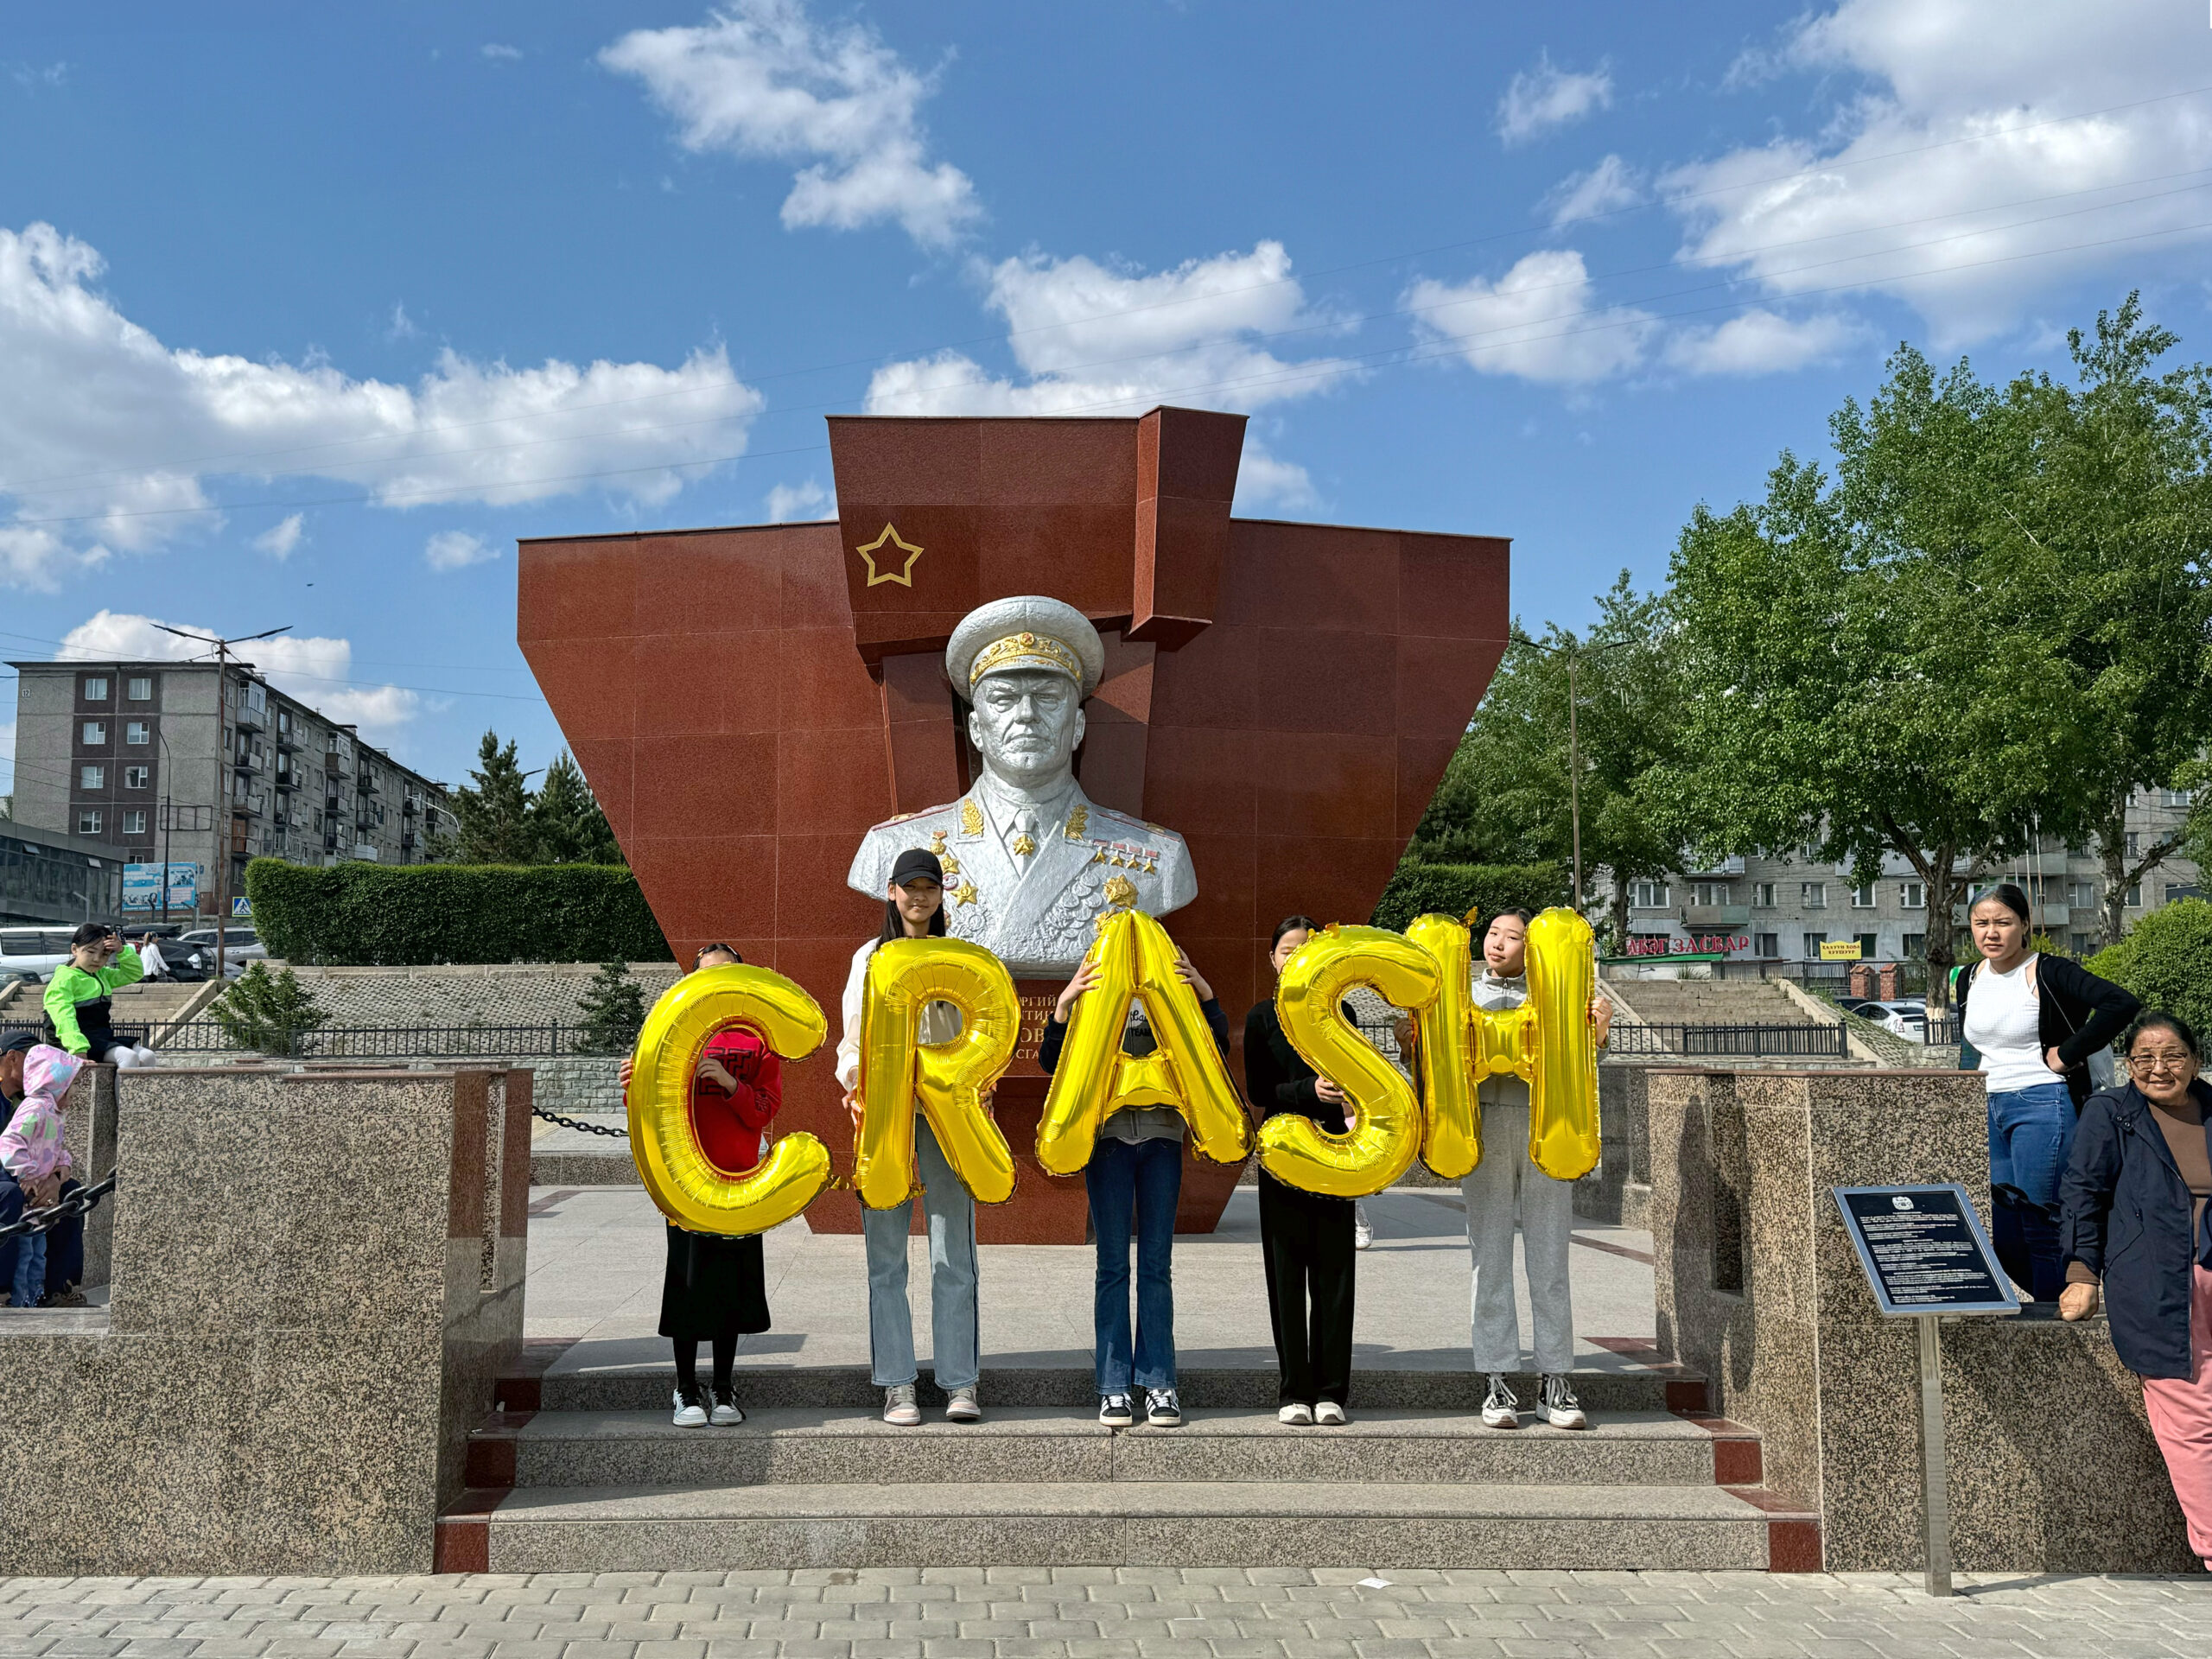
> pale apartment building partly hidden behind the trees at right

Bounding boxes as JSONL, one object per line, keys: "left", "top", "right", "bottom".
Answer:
{"left": 1608, "top": 790, "right": 2203, "bottom": 963}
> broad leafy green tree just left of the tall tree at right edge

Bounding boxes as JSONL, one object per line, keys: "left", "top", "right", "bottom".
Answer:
{"left": 1672, "top": 345, "right": 2073, "bottom": 998}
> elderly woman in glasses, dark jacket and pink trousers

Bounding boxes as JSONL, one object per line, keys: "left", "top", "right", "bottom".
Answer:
{"left": 2059, "top": 1013, "right": 2212, "bottom": 1571}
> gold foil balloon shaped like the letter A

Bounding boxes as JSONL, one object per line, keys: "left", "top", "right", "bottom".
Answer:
{"left": 1038, "top": 909, "right": 1252, "bottom": 1174}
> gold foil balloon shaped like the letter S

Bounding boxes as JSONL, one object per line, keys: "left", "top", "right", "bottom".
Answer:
{"left": 1259, "top": 927, "right": 1438, "bottom": 1199}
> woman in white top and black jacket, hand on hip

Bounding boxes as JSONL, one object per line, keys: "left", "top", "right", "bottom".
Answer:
{"left": 1958, "top": 882, "right": 2141, "bottom": 1303}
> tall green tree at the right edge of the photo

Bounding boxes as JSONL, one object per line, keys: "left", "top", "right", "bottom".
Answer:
{"left": 1991, "top": 294, "right": 2212, "bottom": 944}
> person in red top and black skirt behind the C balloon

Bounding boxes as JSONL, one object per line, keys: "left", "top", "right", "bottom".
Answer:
{"left": 621, "top": 944, "right": 783, "bottom": 1429}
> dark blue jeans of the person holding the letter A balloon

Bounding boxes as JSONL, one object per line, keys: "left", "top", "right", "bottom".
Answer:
{"left": 1084, "top": 1135, "right": 1184, "bottom": 1394}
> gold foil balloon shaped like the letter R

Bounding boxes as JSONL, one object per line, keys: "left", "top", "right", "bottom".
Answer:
{"left": 852, "top": 938, "right": 1022, "bottom": 1210}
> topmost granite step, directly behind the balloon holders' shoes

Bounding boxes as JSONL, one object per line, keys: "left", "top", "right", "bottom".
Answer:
{"left": 526, "top": 1350, "right": 1706, "bottom": 1415}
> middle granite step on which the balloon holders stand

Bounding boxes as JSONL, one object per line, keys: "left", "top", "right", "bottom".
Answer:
{"left": 469, "top": 1407, "right": 1761, "bottom": 1489}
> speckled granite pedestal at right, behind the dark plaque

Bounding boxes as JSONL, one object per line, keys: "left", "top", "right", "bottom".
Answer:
{"left": 1645, "top": 1066, "right": 2196, "bottom": 1573}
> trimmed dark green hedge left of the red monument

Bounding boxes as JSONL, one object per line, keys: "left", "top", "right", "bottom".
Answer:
{"left": 245, "top": 858, "right": 672, "bottom": 967}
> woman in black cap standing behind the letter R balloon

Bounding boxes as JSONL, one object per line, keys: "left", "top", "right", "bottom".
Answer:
{"left": 836, "top": 847, "right": 982, "bottom": 1429}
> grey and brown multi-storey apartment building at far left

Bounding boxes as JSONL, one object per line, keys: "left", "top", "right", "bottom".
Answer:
{"left": 9, "top": 661, "right": 458, "bottom": 925}
